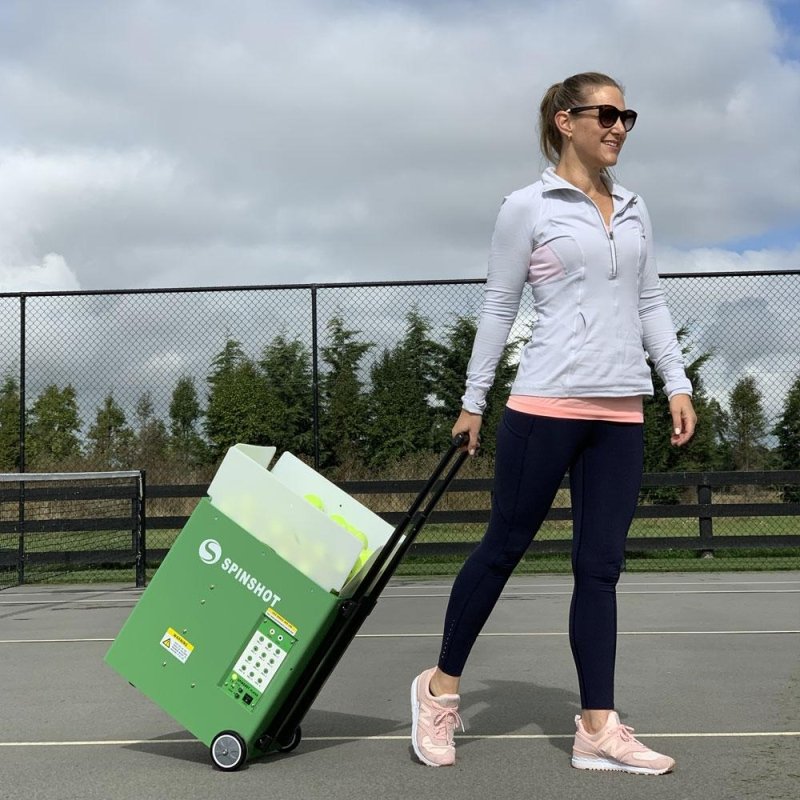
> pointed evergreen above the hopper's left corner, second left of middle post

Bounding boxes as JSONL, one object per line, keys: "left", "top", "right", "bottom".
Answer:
{"left": 204, "top": 339, "right": 271, "bottom": 461}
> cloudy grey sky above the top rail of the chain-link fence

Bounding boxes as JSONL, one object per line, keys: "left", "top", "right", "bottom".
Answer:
{"left": 0, "top": 0, "right": 800, "bottom": 292}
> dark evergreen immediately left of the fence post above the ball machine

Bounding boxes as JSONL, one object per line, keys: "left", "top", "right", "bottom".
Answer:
{"left": 259, "top": 336, "right": 314, "bottom": 455}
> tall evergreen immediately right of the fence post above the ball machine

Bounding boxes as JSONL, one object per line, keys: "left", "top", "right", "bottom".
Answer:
{"left": 319, "top": 315, "right": 374, "bottom": 467}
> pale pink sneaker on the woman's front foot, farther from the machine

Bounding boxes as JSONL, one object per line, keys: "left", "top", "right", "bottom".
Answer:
{"left": 572, "top": 711, "right": 675, "bottom": 775}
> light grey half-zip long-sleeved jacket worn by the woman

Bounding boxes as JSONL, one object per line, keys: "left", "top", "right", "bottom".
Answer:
{"left": 462, "top": 168, "right": 692, "bottom": 413}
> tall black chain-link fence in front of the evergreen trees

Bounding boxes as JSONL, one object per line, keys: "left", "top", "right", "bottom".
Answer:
{"left": 0, "top": 271, "right": 800, "bottom": 580}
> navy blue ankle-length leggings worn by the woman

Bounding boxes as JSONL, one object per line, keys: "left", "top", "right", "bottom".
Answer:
{"left": 439, "top": 408, "right": 643, "bottom": 709}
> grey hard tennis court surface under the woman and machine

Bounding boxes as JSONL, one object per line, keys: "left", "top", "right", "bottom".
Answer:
{"left": 0, "top": 572, "right": 800, "bottom": 800}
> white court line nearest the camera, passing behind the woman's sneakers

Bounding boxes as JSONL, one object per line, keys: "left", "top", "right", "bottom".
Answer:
{"left": 0, "top": 731, "right": 800, "bottom": 747}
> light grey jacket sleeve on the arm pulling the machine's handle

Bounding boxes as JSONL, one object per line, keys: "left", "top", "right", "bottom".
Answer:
{"left": 461, "top": 195, "right": 532, "bottom": 414}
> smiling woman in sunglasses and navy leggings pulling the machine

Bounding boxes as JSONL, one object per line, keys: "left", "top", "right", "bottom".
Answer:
{"left": 411, "top": 73, "right": 696, "bottom": 774}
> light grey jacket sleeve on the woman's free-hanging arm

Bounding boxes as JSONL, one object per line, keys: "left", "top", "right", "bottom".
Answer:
{"left": 637, "top": 198, "right": 692, "bottom": 399}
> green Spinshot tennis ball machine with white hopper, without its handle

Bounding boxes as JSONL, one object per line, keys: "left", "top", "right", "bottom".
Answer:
{"left": 106, "top": 444, "right": 393, "bottom": 770}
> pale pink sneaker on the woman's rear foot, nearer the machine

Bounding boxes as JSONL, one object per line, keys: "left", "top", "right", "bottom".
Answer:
{"left": 411, "top": 668, "right": 464, "bottom": 767}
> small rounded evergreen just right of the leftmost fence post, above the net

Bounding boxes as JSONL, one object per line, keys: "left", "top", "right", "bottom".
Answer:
{"left": 26, "top": 385, "right": 81, "bottom": 471}
